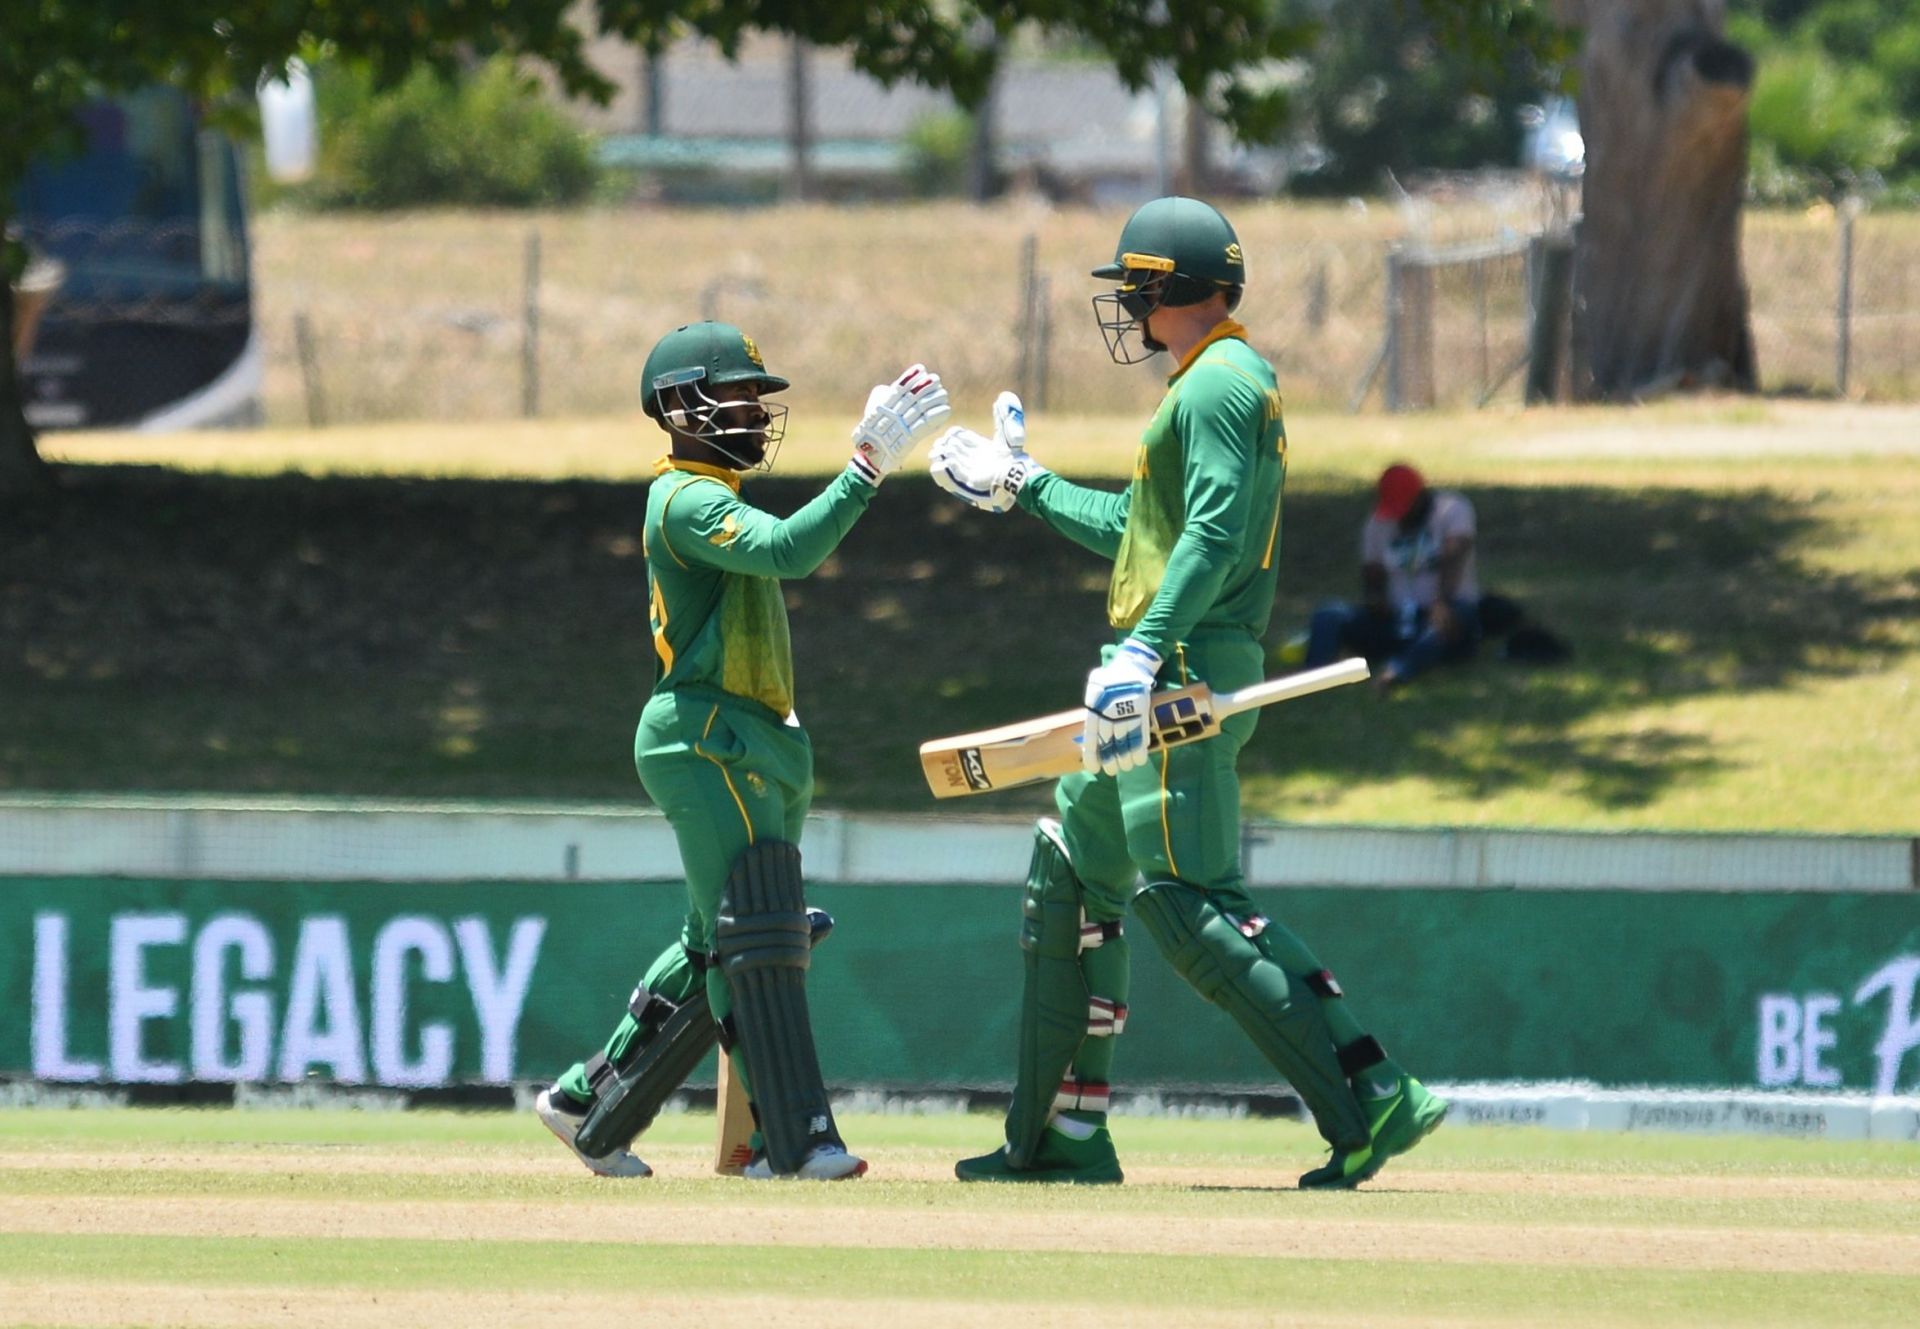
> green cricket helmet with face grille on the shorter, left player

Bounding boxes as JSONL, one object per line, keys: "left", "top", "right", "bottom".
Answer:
{"left": 639, "top": 323, "right": 791, "bottom": 471}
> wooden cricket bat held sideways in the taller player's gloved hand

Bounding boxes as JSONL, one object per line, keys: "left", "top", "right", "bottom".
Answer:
{"left": 920, "top": 657, "right": 1367, "bottom": 799}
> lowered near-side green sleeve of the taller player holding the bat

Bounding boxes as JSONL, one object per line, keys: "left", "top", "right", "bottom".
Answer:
{"left": 1133, "top": 363, "right": 1267, "bottom": 657}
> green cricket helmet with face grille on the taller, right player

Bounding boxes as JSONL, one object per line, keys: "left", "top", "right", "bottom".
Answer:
{"left": 1092, "top": 198, "right": 1246, "bottom": 365}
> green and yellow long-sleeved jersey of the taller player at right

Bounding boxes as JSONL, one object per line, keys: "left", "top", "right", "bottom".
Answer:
{"left": 1018, "top": 321, "right": 1286, "bottom": 659}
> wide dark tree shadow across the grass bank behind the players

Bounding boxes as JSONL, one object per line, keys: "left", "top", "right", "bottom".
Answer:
{"left": 0, "top": 467, "right": 1920, "bottom": 810}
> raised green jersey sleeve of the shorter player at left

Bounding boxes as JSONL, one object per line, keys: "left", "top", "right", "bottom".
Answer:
{"left": 660, "top": 471, "right": 874, "bottom": 580}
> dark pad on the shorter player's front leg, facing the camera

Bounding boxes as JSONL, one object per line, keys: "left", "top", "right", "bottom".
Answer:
{"left": 714, "top": 839, "right": 845, "bottom": 1175}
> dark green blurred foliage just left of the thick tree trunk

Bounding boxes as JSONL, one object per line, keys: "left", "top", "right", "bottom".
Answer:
{"left": 1294, "top": 0, "right": 1548, "bottom": 194}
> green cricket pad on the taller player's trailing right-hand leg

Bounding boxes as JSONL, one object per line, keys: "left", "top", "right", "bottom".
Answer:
{"left": 1133, "top": 882, "right": 1369, "bottom": 1150}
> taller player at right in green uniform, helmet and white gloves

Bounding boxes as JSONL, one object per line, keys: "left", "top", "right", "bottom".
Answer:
{"left": 931, "top": 198, "right": 1448, "bottom": 1189}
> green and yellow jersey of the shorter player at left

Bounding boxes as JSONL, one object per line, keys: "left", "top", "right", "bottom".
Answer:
{"left": 643, "top": 457, "right": 874, "bottom": 716}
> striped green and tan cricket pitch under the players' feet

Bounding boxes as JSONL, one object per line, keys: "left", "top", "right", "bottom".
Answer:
{"left": 0, "top": 1108, "right": 1920, "bottom": 1329}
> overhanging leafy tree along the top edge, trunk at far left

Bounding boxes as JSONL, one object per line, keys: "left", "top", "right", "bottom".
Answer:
{"left": 0, "top": 0, "right": 1540, "bottom": 494}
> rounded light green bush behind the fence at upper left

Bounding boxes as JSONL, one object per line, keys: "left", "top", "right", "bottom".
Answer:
{"left": 294, "top": 58, "right": 599, "bottom": 207}
